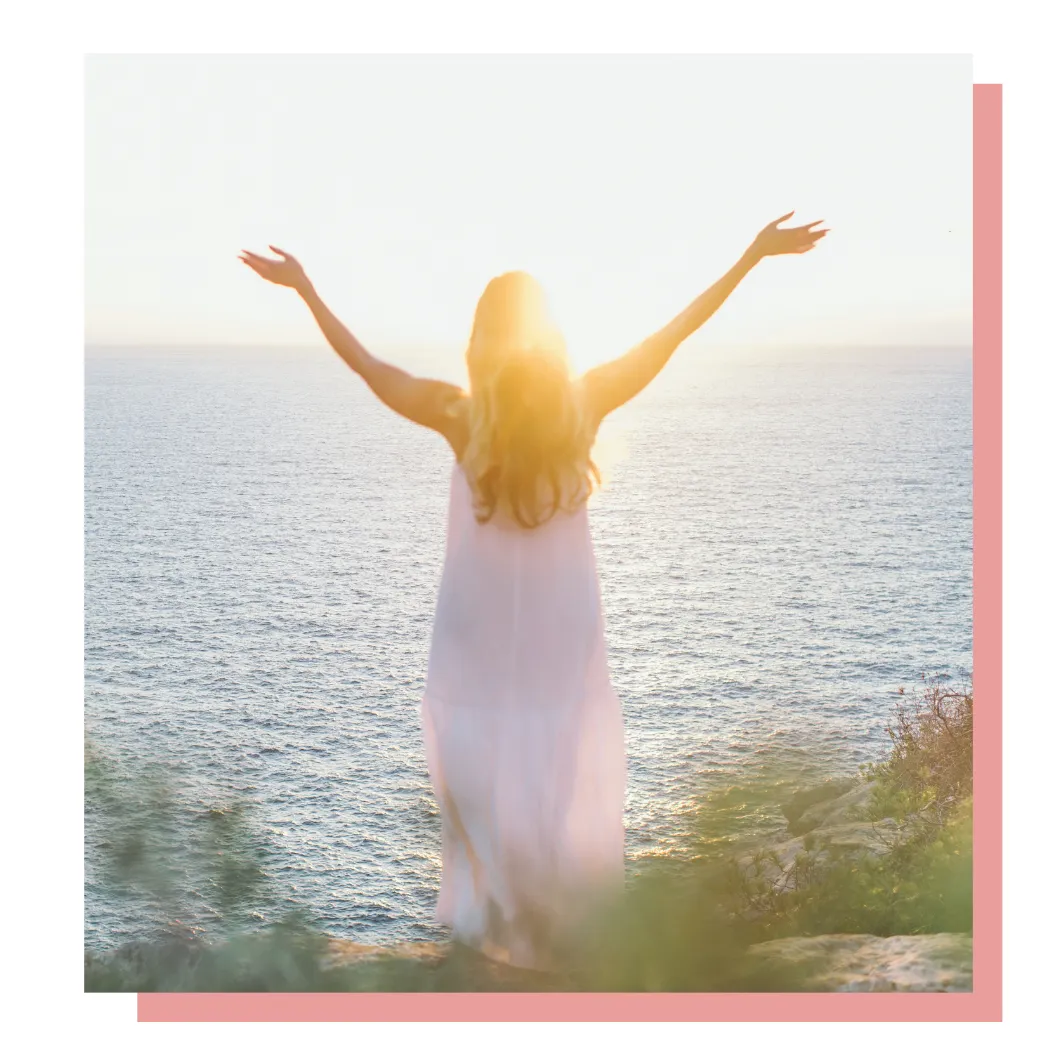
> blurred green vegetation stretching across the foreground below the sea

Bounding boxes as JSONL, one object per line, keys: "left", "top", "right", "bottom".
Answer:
{"left": 85, "top": 680, "right": 974, "bottom": 992}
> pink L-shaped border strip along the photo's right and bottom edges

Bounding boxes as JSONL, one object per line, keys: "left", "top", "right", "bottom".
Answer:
{"left": 137, "top": 85, "right": 1002, "bottom": 1023}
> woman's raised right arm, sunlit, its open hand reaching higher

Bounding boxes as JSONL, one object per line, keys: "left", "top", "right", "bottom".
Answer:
{"left": 583, "top": 210, "right": 827, "bottom": 421}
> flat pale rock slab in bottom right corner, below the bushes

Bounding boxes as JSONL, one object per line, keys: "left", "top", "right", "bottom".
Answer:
{"left": 749, "top": 933, "right": 973, "bottom": 993}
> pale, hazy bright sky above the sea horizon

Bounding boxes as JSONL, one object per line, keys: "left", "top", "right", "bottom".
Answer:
{"left": 85, "top": 56, "right": 973, "bottom": 374}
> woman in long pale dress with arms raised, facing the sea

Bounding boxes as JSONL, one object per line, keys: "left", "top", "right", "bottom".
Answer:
{"left": 240, "top": 212, "right": 827, "bottom": 967}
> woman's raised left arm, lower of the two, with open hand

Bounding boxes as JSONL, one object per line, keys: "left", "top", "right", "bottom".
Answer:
{"left": 240, "top": 244, "right": 462, "bottom": 449}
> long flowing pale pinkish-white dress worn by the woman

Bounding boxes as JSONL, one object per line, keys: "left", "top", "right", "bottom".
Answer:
{"left": 421, "top": 465, "right": 626, "bottom": 967}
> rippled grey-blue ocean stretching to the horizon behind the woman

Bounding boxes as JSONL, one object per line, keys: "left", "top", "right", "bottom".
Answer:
{"left": 85, "top": 344, "right": 972, "bottom": 948}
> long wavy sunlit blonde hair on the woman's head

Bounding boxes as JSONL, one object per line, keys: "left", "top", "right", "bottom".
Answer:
{"left": 461, "top": 272, "right": 602, "bottom": 528}
